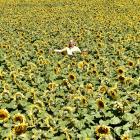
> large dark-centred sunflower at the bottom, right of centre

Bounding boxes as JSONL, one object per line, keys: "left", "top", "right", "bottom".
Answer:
{"left": 95, "top": 125, "right": 110, "bottom": 137}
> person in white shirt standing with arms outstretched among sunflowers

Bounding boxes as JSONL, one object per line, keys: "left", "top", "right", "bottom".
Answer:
{"left": 54, "top": 39, "right": 81, "bottom": 55}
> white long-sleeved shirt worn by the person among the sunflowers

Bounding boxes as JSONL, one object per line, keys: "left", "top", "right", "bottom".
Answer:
{"left": 54, "top": 46, "right": 81, "bottom": 55}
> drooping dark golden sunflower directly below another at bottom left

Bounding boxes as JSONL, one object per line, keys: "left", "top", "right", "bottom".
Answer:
{"left": 13, "top": 123, "right": 27, "bottom": 135}
